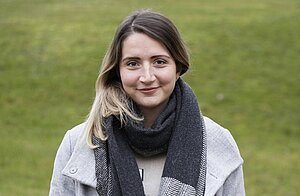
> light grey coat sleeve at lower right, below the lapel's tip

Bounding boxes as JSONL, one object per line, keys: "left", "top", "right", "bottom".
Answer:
{"left": 216, "top": 165, "right": 245, "bottom": 196}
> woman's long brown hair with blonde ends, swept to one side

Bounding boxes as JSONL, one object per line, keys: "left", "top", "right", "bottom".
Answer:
{"left": 86, "top": 10, "right": 190, "bottom": 147}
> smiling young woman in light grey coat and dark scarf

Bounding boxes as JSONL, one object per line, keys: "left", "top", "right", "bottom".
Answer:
{"left": 50, "top": 10, "right": 245, "bottom": 196}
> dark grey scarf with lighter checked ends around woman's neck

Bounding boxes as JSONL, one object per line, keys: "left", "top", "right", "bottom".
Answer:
{"left": 93, "top": 78, "right": 206, "bottom": 196}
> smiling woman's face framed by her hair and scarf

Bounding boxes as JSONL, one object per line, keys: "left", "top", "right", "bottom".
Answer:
{"left": 119, "top": 33, "right": 180, "bottom": 112}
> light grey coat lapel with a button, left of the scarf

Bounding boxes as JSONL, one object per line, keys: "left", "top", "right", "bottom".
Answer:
{"left": 62, "top": 134, "right": 97, "bottom": 188}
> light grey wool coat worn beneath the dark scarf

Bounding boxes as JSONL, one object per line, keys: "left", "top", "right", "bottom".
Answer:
{"left": 49, "top": 117, "right": 245, "bottom": 196}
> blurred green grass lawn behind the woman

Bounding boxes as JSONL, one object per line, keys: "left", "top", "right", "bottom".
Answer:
{"left": 0, "top": 0, "right": 300, "bottom": 196}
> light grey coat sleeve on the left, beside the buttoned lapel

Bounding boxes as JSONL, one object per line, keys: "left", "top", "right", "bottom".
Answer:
{"left": 49, "top": 131, "right": 75, "bottom": 196}
